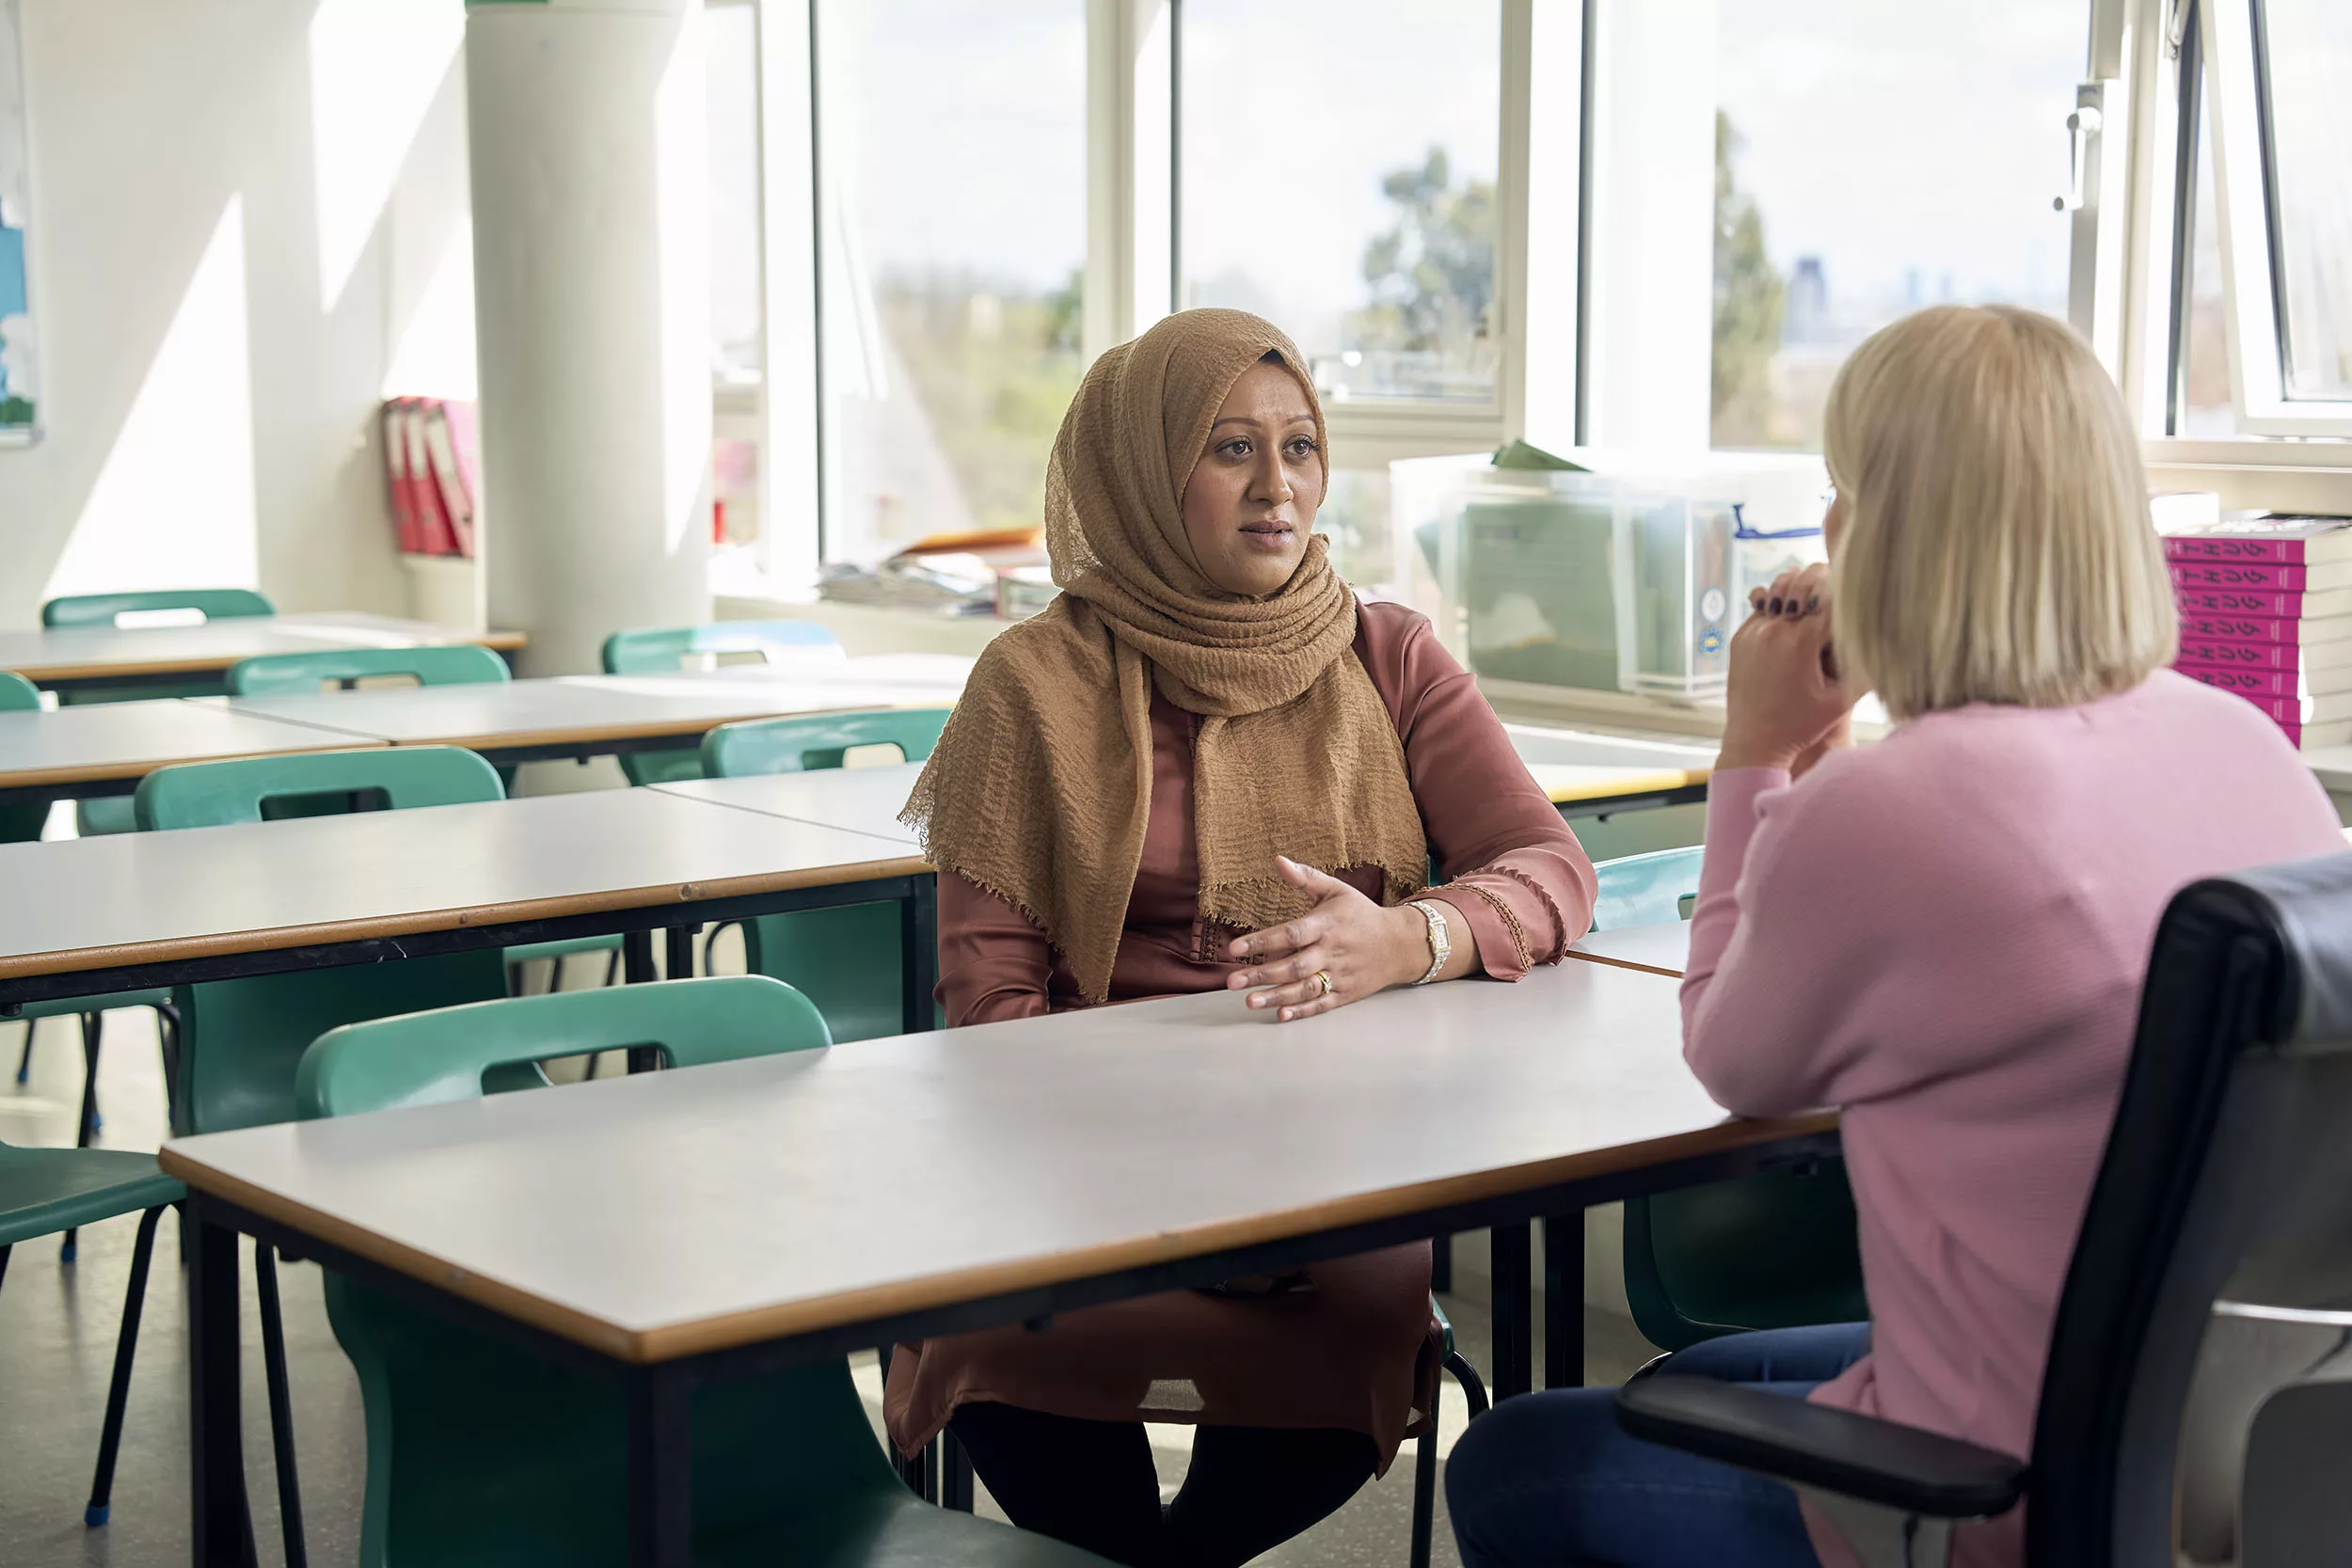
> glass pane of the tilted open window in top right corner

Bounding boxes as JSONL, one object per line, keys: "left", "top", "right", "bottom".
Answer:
{"left": 2256, "top": 0, "right": 2352, "bottom": 397}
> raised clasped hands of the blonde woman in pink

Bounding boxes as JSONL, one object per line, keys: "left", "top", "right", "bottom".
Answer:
{"left": 1715, "top": 566, "right": 1853, "bottom": 771}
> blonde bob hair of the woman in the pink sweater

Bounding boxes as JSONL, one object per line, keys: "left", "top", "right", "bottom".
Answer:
{"left": 1823, "top": 306, "right": 2178, "bottom": 720}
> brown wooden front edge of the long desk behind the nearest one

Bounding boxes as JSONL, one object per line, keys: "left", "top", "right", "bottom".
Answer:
{"left": 0, "top": 860, "right": 931, "bottom": 980}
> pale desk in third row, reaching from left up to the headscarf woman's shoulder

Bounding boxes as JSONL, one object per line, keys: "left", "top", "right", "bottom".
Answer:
{"left": 188, "top": 658, "right": 962, "bottom": 764}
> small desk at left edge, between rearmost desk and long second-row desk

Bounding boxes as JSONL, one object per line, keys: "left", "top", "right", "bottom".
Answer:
{"left": 0, "top": 701, "right": 384, "bottom": 806}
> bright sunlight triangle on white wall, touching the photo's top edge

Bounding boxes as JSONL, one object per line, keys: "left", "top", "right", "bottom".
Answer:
{"left": 310, "top": 0, "right": 466, "bottom": 310}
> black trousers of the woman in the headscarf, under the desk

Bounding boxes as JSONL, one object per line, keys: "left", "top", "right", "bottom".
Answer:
{"left": 953, "top": 1403, "right": 1381, "bottom": 1568}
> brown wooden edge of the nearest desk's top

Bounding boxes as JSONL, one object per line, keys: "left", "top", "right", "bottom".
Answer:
{"left": 160, "top": 1110, "right": 1837, "bottom": 1366}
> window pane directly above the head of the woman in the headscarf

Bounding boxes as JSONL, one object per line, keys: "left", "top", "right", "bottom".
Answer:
{"left": 1179, "top": 0, "right": 1503, "bottom": 402}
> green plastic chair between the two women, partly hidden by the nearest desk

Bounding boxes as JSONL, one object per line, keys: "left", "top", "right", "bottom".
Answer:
{"left": 1593, "top": 847, "right": 1870, "bottom": 1350}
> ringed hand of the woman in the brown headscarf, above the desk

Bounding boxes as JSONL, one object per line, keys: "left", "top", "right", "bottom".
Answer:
{"left": 1226, "top": 856, "right": 1430, "bottom": 1022}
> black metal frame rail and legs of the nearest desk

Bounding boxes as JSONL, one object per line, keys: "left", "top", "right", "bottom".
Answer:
{"left": 188, "top": 1131, "right": 1839, "bottom": 1568}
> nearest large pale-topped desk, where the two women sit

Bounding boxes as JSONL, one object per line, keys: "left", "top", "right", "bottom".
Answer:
{"left": 163, "top": 958, "right": 1835, "bottom": 1568}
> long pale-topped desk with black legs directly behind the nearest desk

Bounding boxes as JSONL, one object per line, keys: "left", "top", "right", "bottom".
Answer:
{"left": 0, "top": 790, "right": 939, "bottom": 1030}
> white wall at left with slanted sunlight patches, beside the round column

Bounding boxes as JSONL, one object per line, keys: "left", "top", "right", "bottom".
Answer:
{"left": 0, "top": 0, "right": 470, "bottom": 626}
